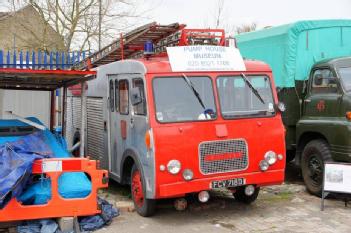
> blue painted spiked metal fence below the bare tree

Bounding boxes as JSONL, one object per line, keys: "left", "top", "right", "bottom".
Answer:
{"left": 0, "top": 50, "right": 86, "bottom": 70}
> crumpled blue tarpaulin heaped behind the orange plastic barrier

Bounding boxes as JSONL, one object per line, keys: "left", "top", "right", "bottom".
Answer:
{"left": 0, "top": 118, "right": 91, "bottom": 208}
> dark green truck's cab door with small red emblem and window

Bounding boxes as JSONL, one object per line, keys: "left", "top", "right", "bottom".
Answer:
{"left": 304, "top": 68, "right": 341, "bottom": 118}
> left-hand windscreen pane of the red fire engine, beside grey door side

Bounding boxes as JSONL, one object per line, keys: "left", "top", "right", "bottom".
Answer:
{"left": 153, "top": 76, "right": 217, "bottom": 122}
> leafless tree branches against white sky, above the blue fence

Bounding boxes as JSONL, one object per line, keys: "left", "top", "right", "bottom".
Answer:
{"left": 8, "top": 0, "right": 147, "bottom": 51}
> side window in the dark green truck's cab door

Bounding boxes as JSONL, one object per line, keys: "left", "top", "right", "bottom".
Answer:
{"left": 311, "top": 69, "right": 338, "bottom": 94}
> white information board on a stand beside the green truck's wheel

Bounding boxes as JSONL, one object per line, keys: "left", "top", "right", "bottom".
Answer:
{"left": 321, "top": 162, "right": 351, "bottom": 211}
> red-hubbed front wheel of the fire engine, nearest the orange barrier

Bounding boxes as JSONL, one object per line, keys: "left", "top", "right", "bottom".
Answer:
{"left": 130, "top": 164, "right": 156, "bottom": 217}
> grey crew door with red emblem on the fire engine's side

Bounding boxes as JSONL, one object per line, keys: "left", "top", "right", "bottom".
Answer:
{"left": 109, "top": 75, "right": 130, "bottom": 179}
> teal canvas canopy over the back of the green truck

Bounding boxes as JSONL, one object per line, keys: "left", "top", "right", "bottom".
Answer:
{"left": 236, "top": 20, "right": 351, "bottom": 87}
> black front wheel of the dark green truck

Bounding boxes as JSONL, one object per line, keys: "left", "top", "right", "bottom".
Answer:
{"left": 301, "top": 139, "right": 331, "bottom": 197}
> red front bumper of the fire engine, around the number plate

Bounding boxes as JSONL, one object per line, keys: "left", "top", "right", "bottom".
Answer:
{"left": 156, "top": 169, "right": 285, "bottom": 198}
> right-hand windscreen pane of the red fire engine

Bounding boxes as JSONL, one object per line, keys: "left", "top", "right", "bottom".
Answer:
{"left": 217, "top": 76, "right": 275, "bottom": 119}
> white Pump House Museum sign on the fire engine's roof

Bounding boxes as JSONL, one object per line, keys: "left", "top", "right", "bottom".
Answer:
{"left": 167, "top": 46, "right": 246, "bottom": 72}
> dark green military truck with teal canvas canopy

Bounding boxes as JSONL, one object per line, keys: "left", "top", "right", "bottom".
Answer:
{"left": 236, "top": 20, "right": 351, "bottom": 196}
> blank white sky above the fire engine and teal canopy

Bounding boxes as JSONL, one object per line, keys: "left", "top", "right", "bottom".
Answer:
{"left": 145, "top": 0, "right": 351, "bottom": 33}
